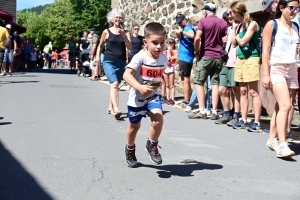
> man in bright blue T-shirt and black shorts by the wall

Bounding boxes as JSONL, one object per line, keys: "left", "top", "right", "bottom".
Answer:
{"left": 176, "top": 14, "right": 195, "bottom": 104}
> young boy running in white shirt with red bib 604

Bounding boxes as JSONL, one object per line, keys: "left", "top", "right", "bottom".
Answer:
{"left": 123, "top": 22, "right": 168, "bottom": 167}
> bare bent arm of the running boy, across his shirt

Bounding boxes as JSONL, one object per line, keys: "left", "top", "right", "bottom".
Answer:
{"left": 123, "top": 67, "right": 154, "bottom": 96}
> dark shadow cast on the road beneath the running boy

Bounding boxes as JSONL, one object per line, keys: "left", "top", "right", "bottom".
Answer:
{"left": 138, "top": 161, "right": 223, "bottom": 178}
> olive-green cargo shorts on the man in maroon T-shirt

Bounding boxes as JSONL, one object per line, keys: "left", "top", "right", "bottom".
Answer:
{"left": 194, "top": 57, "right": 223, "bottom": 86}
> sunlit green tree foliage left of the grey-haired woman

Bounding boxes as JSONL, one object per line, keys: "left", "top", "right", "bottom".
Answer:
{"left": 17, "top": 0, "right": 111, "bottom": 48}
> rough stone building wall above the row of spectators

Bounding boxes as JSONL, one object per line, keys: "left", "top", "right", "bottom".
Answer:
{"left": 111, "top": 0, "right": 262, "bottom": 37}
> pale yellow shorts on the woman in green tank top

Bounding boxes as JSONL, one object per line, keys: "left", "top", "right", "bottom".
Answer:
{"left": 234, "top": 57, "right": 260, "bottom": 83}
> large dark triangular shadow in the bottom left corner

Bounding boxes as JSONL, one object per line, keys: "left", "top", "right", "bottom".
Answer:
{"left": 0, "top": 142, "right": 53, "bottom": 200}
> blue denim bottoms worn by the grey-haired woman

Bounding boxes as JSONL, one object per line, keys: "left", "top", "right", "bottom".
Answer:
{"left": 103, "top": 60, "right": 126, "bottom": 83}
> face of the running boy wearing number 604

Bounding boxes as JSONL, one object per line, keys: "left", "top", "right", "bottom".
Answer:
{"left": 144, "top": 35, "right": 167, "bottom": 59}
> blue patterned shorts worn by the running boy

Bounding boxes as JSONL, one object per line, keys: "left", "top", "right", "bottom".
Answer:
{"left": 127, "top": 95, "right": 162, "bottom": 124}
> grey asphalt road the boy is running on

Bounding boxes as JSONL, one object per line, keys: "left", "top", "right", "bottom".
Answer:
{"left": 0, "top": 69, "right": 300, "bottom": 200}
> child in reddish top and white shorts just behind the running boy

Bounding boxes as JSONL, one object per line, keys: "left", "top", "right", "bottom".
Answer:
{"left": 164, "top": 39, "right": 177, "bottom": 105}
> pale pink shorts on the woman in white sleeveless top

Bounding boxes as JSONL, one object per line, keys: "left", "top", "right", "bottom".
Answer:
{"left": 270, "top": 63, "right": 299, "bottom": 89}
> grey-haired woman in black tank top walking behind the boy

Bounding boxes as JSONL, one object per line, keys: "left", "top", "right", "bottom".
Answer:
{"left": 96, "top": 8, "right": 132, "bottom": 119}
